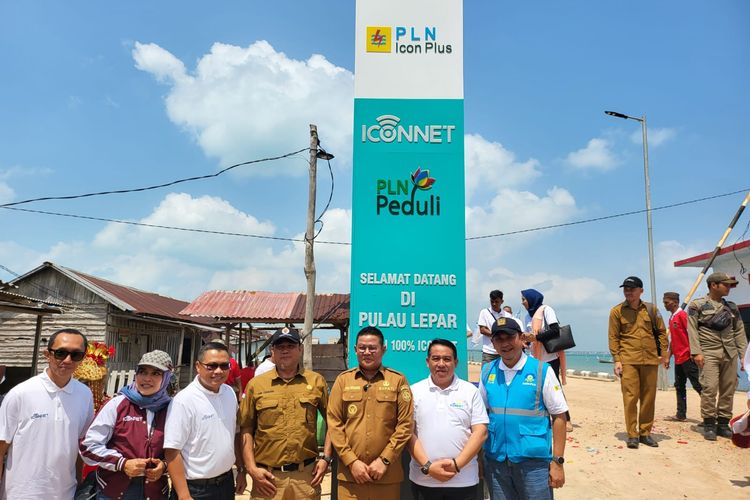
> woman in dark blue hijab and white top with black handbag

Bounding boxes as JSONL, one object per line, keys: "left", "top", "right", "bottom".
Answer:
{"left": 521, "top": 288, "right": 573, "bottom": 432}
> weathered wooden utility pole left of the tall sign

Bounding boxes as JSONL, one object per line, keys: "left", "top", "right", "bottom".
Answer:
{"left": 302, "top": 124, "right": 319, "bottom": 370}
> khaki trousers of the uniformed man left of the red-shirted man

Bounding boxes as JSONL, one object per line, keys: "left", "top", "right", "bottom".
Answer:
{"left": 620, "top": 365, "right": 659, "bottom": 438}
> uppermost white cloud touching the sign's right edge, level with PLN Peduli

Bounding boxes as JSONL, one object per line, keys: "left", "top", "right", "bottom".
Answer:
{"left": 464, "top": 134, "right": 541, "bottom": 200}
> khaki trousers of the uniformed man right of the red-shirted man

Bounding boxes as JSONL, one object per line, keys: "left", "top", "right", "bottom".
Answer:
{"left": 700, "top": 352, "right": 737, "bottom": 421}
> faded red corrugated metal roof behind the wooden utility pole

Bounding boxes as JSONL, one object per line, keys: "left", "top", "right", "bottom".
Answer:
{"left": 180, "top": 290, "right": 349, "bottom": 323}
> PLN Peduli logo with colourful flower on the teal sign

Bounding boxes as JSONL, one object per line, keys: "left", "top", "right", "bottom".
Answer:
{"left": 375, "top": 167, "right": 440, "bottom": 217}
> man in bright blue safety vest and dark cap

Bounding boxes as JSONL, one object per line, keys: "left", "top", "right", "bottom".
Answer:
{"left": 479, "top": 318, "right": 568, "bottom": 500}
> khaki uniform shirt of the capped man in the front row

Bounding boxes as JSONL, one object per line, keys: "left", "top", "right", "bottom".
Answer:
{"left": 240, "top": 368, "right": 328, "bottom": 467}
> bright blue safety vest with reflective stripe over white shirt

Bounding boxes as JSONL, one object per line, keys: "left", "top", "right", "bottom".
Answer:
{"left": 482, "top": 356, "right": 552, "bottom": 463}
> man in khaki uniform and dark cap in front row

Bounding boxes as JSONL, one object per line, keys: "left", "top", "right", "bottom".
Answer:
{"left": 240, "top": 328, "right": 333, "bottom": 500}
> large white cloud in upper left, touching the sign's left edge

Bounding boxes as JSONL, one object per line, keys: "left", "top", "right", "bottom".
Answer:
{"left": 133, "top": 41, "right": 354, "bottom": 175}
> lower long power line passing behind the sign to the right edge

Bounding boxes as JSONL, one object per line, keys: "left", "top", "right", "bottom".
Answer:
{"left": 0, "top": 188, "right": 750, "bottom": 245}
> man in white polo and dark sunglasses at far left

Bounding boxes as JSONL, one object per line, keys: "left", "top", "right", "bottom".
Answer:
{"left": 0, "top": 328, "right": 94, "bottom": 500}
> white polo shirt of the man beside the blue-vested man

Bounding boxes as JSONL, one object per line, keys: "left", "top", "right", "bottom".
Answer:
{"left": 409, "top": 376, "right": 489, "bottom": 488}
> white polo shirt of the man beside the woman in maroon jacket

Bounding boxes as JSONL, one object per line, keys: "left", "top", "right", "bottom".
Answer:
{"left": 164, "top": 377, "right": 237, "bottom": 479}
